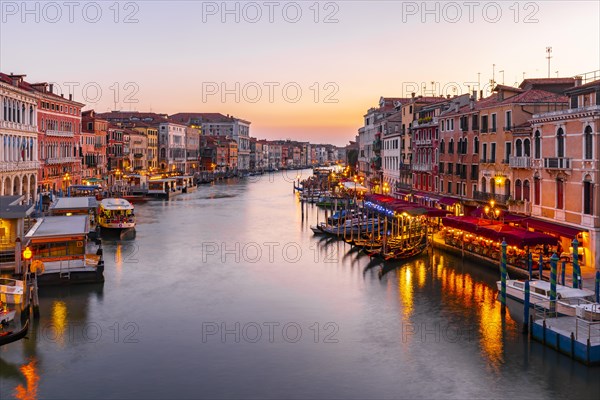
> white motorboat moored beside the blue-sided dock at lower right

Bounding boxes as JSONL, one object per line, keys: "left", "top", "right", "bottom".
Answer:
{"left": 497, "top": 279, "right": 600, "bottom": 320}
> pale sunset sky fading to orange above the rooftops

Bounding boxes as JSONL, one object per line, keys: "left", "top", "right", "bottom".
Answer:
{"left": 0, "top": 1, "right": 600, "bottom": 145}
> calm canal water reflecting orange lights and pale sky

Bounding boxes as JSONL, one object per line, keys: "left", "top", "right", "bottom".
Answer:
{"left": 0, "top": 171, "right": 600, "bottom": 399}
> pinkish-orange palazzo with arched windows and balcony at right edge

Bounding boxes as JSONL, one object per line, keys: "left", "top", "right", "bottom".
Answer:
{"left": 531, "top": 81, "right": 600, "bottom": 269}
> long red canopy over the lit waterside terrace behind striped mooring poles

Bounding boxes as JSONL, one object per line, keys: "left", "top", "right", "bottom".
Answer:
{"left": 442, "top": 217, "right": 557, "bottom": 247}
